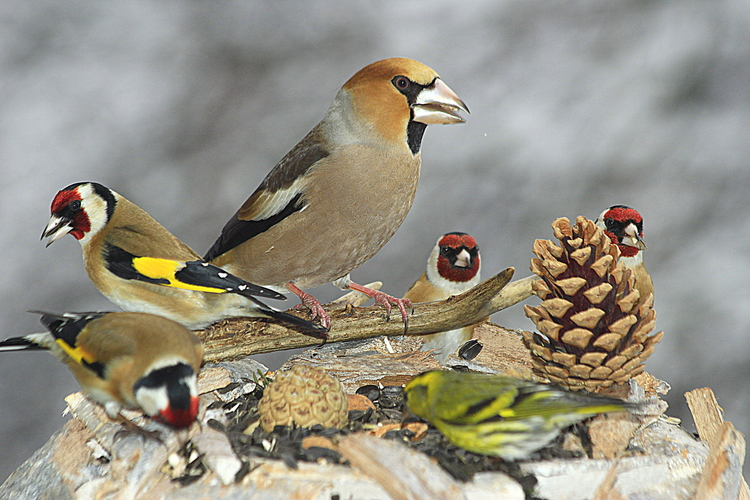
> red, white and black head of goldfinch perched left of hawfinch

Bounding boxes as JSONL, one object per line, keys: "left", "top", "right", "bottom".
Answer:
{"left": 42, "top": 182, "right": 116, "bottom": 246}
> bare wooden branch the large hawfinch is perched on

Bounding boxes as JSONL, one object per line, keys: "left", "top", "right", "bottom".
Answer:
{"left": 196, "top": 267, "right": 537, "bottom": 362}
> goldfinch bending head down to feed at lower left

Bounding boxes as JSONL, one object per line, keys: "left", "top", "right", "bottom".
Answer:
{"left": 0, "top": 312, "right": 203, "bottom": 427}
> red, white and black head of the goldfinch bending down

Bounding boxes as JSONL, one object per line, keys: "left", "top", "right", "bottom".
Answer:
{"left": 133, "top": 359, "right": 199, "bottom": 427}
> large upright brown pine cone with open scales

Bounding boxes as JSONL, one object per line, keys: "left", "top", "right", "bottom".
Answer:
{"left": 524, "top": 217, "right": 664, "bottom": 392}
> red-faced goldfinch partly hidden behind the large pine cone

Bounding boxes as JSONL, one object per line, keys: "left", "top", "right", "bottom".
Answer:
{"left": 596, "top": 205, "right": 654, "bottom": 302}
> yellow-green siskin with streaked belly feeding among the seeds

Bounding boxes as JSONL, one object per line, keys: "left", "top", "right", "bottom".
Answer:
{"left": 404, "top": 370, "right": 632, "bottom": 460}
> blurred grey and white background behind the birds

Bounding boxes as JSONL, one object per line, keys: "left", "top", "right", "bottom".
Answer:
{"left": 0, "top": 0, "right": 750, "bottom": 480}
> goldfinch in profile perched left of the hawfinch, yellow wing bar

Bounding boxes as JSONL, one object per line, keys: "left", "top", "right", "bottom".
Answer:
{"left": 42, "top": 182, "right": 322, "bottom": 331}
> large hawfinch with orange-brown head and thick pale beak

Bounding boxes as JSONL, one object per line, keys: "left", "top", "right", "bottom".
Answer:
{"left": 204, "top": 58, "right": 468, "bottom": 328}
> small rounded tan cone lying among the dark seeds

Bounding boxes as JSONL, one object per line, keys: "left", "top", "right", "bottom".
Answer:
{"left": 258, "top": 365, "right": 348, "bottom": 432}
